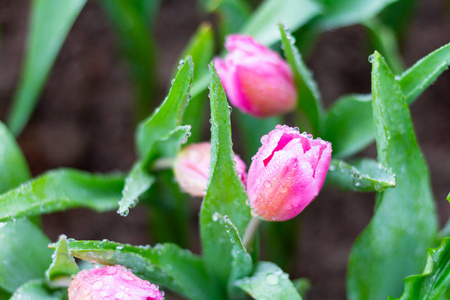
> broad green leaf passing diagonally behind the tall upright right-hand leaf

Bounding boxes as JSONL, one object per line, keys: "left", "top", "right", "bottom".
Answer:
{"left": 324, "top": 44, "right": 450, "bottom": 157}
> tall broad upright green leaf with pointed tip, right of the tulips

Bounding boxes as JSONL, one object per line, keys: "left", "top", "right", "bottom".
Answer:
{"left": 347, "top": 52, "right": 437, "bottom": 300}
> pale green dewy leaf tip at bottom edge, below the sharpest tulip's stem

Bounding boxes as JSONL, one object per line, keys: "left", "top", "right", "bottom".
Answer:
{"left": 236, "top": 262, "right": 302, "bottom": 300}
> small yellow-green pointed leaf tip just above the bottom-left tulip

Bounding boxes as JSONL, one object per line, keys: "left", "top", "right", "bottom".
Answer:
{"left": 45, "top": 235, "right": 78, "bottom": 287}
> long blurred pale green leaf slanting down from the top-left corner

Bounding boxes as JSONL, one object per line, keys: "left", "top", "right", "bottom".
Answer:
{"left": 8, "top": 0, "right": 86, "bottom": 135}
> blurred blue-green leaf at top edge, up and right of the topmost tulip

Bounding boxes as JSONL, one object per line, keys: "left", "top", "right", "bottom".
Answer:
{"left": 313, "top": 0, "right": 397, "bottom": 31}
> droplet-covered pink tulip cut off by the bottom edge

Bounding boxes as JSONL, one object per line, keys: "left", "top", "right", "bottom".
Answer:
{"left": 69, "top": 266, "right": 164, "bottom": 300}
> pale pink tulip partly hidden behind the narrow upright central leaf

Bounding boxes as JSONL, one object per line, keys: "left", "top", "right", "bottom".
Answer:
{"left": 173, "top": 142, "right": 247, "bottom": 196}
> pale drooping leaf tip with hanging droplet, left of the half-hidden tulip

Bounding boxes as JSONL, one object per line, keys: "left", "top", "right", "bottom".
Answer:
{"left": 117, "top": 161, "right": 155, "bottom": 216}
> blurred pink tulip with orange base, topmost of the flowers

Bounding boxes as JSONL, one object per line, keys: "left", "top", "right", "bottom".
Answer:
{"left": 214, "top": 34, "right": 297, "bottom": 117}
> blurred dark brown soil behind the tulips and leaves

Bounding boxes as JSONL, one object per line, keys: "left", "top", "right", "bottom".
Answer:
{"left": 0, "top": 0, "right": 450, "bottom": 300}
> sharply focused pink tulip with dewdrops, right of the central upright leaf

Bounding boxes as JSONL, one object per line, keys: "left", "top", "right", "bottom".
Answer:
{"left": 247, "top": 125, "right": 331, "bottom": 221}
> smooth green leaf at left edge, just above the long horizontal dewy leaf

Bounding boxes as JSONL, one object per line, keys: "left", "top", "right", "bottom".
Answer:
{"left": 0, "top": 122, "right": 31, "bottom": 193}
